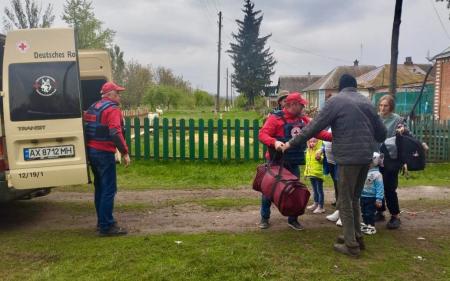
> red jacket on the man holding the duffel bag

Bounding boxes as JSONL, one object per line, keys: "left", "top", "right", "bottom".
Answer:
{"left": 258, "top": 109, "right": 332, "bottom": 156}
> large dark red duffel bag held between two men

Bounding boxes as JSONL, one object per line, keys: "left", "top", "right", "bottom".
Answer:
{"left": 253, "top": 161, "right": 311, "bottom": 216}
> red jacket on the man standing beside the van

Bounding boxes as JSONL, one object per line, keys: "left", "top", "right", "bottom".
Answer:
{"left": 87, "top": 98, "right": 128, "bottom": 154}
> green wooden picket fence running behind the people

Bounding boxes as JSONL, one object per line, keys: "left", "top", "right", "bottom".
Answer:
{"left": 125, "top": 114, "right": 450, "bottom": 162}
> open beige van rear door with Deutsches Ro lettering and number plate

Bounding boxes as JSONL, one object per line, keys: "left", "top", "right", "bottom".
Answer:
{"left": 3, "top": 28, "right": 88, "bottom": 189}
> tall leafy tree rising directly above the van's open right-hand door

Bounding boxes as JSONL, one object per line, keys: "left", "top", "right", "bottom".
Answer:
{"left": 62, "top": 0, "right": 115, "bottom": 49}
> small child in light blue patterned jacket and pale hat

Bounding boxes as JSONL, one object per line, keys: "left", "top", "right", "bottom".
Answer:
{"left": 360, "top": 152, "right": 384, "bottom": 235}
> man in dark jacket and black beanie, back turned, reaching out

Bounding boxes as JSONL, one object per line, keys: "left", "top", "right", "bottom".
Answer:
{"left": 283, "top": 74, "right": 386, "bottom": 256}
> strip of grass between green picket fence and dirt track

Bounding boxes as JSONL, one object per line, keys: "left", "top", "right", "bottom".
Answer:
{"left": 58, "top": 161, "right": 450, "bottom": 191}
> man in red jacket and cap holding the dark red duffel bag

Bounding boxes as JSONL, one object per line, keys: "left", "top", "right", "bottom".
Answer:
{"left": 259, "top": 92, "right": 331, "bottom": 230}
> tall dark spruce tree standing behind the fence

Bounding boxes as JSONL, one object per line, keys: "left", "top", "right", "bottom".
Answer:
{"left": 228, "top": 0, "right": 276, "bottom": 106}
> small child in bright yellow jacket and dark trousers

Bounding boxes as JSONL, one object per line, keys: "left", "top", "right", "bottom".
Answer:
{"left": 304, "top": 138, "right": 325, "bottom": 214}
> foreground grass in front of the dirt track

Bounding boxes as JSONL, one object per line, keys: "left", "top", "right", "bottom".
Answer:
{"left": 0, "top": 229, "right": 450, "bottom": 280}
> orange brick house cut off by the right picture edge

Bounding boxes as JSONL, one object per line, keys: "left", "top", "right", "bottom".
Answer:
{"left": 433, "top": 47, "right": 450, "bottom": 120}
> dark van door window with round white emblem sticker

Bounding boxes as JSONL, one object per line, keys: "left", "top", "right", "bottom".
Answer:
{"left": 9, "top": 62, "right": 81, "bottom": 121}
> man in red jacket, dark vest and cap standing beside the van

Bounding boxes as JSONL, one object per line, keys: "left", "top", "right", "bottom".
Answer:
{"left": 84, "top": 82, "right": 130, "bottom": 236}
